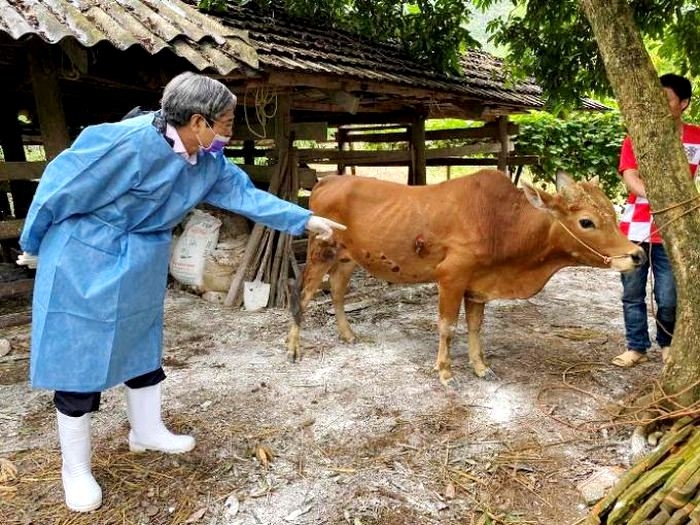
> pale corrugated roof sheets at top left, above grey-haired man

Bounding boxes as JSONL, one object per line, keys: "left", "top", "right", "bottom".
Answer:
{"left": 0, "top": 0, "right": 258, "bottom": 75}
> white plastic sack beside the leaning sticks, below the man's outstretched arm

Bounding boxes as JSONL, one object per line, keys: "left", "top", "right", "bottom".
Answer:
{"left": 170, "top": 210, "right": 221, "bottom": 286}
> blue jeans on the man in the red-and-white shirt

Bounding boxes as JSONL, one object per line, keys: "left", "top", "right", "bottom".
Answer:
{"left": 622, "top": 242, "right": 676, "bottom": 353}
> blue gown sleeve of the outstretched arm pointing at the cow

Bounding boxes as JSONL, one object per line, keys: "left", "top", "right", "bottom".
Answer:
{"left": 204, "top": 155, "right": 311, "bottom": 235}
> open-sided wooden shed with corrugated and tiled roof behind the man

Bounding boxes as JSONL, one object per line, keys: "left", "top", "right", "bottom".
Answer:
{"left": 0, "top": 0, "right": 602, "bottom": 310}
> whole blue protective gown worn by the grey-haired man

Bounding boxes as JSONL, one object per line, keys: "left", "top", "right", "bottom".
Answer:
{"left": 20, "top": 115, "right": 310, "bottom": 392}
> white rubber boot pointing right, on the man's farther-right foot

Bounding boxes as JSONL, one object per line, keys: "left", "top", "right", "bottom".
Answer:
{"left": 126, "top": 383, "right": 195, "bottom": 454}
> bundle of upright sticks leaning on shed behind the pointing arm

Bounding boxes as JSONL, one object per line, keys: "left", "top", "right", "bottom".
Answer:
{"left": 224, "top": 149, "right": 300, "bottom": 308}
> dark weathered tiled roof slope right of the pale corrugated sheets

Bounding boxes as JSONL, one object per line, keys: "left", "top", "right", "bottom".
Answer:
{"left": 209, "top": 1, "right": 606, "bottom": 109}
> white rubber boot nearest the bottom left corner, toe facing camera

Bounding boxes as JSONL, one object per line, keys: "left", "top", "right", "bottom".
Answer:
{"left": 56, "top": 410, "right": 102, "bottom": 512}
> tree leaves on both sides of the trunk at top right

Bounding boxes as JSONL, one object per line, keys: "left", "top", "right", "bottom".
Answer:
{"left": 484, "top": 0, "right": 700, "bottom": 108}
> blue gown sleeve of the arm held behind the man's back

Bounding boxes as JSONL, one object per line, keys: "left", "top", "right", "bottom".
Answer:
{"left": 20, "top": 125, "right": 139, "bottom": 254}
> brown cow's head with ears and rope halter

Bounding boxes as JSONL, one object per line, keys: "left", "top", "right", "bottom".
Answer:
{"left": 523, "top": 172, "right": 646, "bottom": 272}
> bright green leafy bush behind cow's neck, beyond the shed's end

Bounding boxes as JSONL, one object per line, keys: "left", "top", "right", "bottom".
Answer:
{"left": 513, "top": 111, "right": 625, "bottom": 200}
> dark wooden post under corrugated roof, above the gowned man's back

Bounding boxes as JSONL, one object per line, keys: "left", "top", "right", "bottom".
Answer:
{"left": 27, "top": 41, "right": 70, "bottom": 160}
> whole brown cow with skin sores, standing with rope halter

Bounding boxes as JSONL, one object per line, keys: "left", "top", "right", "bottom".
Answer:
{"left": 287, "top": 170, "right": 645, "bottom": 385}
